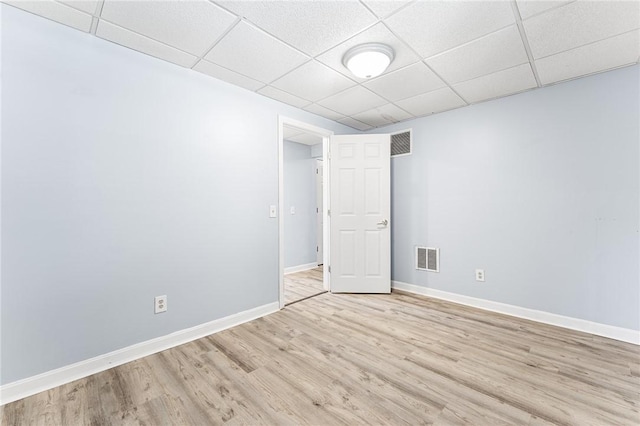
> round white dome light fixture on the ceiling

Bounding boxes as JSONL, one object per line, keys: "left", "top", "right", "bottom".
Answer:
{"left": 342, "top": 43, "right": 394, "bottom": 78}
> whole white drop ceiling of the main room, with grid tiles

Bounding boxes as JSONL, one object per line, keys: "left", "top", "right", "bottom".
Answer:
{"left": 3, "top": 0, "right": 640, "bottom": 130}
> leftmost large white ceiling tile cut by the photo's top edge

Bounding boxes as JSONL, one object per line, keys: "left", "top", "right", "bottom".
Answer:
{"left": 101, "top": 0, "right": 236, "bottom": 56}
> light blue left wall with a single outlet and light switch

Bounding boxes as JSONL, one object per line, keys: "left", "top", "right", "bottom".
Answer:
{"left": 0, "top": 5, "right": 353, "bottom": 384}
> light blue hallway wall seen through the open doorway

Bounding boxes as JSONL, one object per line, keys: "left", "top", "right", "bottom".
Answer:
{"left": 284, "top": 141, "right": 317, "bottom": 268}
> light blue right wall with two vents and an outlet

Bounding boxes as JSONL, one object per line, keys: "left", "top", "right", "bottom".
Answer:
{"left": 376, "top": 66, "right": 640, "bottom": 330}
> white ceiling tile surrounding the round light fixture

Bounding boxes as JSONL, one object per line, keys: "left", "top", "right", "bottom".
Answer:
{"left": 316, "top": 24, "right": 420, "bottom": 82}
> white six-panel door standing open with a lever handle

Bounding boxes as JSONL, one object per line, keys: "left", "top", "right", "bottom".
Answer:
{"left": 329, "top": 135, "right": 391, "bottom": 293}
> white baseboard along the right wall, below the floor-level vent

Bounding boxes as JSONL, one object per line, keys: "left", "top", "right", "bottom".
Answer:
{"left": 391, "top": 281, "right": 640, "bottom": 345}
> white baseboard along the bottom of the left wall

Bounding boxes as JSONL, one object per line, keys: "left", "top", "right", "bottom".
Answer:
{"left": 0, "top": 302, "right": 280, "bottom": 405}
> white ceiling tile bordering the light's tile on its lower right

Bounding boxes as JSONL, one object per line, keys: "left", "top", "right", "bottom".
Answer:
{"left": 364, "top": 62, "right": 445, "bottom": 102}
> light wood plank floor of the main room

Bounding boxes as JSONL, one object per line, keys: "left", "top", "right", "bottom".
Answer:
{"left": 2, "top": 293, "right": 640, "bottom": 425}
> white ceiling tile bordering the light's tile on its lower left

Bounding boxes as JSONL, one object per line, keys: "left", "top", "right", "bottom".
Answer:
{"left": 271, "top": 61, "right": 356, "bottom": 101}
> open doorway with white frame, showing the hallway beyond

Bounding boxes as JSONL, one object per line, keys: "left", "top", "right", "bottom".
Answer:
{"left": 278, "top": 117, "right": 333, "bottom": 308}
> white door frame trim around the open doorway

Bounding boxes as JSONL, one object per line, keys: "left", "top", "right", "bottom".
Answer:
{"left": 278, "top": 115, "right": 333, "bottom": 309}
